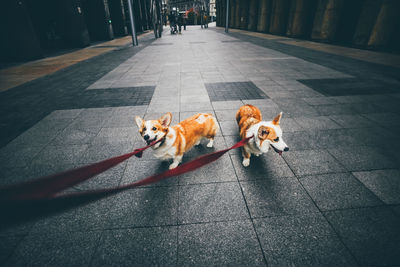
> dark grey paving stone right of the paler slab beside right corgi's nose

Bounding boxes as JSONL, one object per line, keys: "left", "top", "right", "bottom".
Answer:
{"left": 329, "top": 146, "right": 397, "bottom": 171}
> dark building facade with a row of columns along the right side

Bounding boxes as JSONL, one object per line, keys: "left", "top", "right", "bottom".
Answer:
{"left": 216, "top": 0, "right": 400, "bottom": 52}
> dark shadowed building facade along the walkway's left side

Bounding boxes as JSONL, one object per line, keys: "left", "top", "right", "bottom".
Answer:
{"left": 0, "top": 0, "right": 152, "bottom": 61}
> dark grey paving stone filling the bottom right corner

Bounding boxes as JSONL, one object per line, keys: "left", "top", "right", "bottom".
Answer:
{"left": 325, "top": 207, "right": 400, "bottom": 266}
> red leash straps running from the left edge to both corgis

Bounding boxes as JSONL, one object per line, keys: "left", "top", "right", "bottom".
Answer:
{"left": 0, "top": 137, "right": 252, "bottom": 208}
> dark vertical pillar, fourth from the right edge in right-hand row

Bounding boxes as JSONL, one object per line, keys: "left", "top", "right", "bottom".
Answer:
{"left": 286, "top": 0, "right": 317, "bottom": 37}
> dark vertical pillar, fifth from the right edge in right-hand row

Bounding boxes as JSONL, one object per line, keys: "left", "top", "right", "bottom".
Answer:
{"left": 269, "top": 0, "right": 290, "bottom": 34}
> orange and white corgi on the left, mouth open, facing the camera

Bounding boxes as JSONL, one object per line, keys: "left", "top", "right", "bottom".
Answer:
{"left": 135, "top": 112, "right": 218, "bottom": 169}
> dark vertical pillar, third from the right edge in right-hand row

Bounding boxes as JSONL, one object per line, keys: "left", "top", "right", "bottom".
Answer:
{"left": 311, "top": 0, "right": 344, "bottom": 42}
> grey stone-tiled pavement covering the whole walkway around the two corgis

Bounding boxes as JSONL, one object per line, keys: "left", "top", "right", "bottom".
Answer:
{"left": 0, "top": 24, "right": 400, "bottom": 266}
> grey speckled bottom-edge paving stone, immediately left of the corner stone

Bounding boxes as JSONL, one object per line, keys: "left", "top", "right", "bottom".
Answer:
{"left": 255, "top": 213, "right": 357, "bottom": 266}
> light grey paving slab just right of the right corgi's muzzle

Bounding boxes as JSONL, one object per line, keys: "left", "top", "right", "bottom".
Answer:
{"left": 283, "top": 150, "right": 345, "bottom": 176}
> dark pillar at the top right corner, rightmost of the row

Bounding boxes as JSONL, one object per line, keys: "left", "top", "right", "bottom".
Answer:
{"left": 368, "top": 0, "right": 400, "bottom": 48}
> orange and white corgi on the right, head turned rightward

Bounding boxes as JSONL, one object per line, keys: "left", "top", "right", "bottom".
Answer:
{"left": 236, "top": 105, "right": 289, "bottom": 167}
